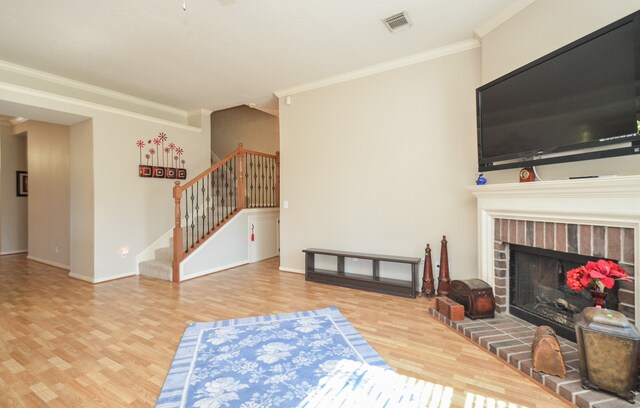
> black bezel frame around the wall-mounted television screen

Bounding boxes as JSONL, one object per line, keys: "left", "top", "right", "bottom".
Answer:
{"left": 476, "top": 11, "right": 640, "bottom": 172}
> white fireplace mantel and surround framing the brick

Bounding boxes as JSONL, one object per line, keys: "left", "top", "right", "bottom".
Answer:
{"left": 469, "top": 176, "right": 640, "bottom": 322}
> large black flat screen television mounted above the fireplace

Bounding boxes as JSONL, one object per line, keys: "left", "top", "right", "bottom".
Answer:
{"left": 476, "top": 11, "right": 640, "bottom": 171}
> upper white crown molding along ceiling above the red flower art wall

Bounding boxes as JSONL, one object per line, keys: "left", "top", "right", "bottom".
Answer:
{"left": 0, "top": 60, "right": 187, "bottom": 117}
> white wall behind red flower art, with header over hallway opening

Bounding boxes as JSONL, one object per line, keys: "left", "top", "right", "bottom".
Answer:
{"left": 0, "top": 66, "right": 211, "bottom": 282}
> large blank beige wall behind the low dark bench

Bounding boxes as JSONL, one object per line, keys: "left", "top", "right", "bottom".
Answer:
{"left": 280, "top": 49, "right": 480, "bottom": 279}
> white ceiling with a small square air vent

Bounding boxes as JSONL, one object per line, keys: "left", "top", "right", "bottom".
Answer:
{"left": 0, "top": 0, "right": 522, "bottom": 115}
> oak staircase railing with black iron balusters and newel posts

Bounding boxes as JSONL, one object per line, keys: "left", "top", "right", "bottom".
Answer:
{"left": 172, "top": 143, "right": 280, "bottom": 282}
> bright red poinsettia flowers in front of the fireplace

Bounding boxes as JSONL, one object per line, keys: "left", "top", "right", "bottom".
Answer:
{"left": 567, "top": 259, "right": 631, "bottom": 292}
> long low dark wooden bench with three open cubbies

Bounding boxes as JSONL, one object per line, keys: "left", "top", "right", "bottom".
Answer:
{"left": 302, "top": 248, "right": 422, "bottom": 298}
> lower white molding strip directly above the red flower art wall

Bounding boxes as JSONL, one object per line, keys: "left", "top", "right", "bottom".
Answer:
{"left": 0, "top": 82, "right": 202, "bottom": 131}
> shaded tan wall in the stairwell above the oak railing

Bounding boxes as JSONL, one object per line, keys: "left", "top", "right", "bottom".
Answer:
{"left": 211, "top": 105, "right": 280, "bottom": 159}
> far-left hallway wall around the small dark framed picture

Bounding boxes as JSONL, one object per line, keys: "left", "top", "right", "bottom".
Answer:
{"left": 0, "top": 125, "right": 28, "bottom": 255}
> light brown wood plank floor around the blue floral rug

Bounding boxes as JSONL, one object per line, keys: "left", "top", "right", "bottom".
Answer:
{"left": 0, "top": 255, "right": 570, "bottom": 407}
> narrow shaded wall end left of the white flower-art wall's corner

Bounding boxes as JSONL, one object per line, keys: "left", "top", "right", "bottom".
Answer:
{"left": 69, "top": 119, "right": 95, "bottom": 280}
